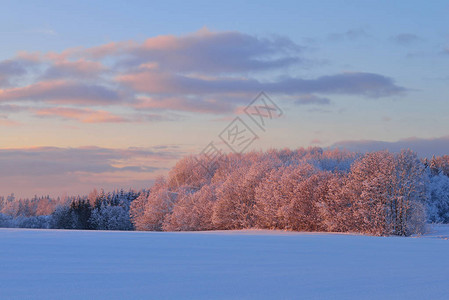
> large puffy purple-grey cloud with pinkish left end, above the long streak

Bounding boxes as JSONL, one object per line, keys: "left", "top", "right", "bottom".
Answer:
{"left": 91, "top": 29, "right": 302, "bottom": 74}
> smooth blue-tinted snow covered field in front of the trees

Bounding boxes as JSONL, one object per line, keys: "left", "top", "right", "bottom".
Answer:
{"left": 0, "top": 226, "right": 449, "bottom": 299}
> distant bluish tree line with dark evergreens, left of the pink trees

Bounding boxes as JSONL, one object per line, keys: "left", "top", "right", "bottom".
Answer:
{"left": 0, "top": 190, "right": 138, "bottom": 230}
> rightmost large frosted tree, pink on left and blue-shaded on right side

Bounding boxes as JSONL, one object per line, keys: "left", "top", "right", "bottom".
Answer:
{"left": 348, "top": 150, "right": 427, "bottom": 235}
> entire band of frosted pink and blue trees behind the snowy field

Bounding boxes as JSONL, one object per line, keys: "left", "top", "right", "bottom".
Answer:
{"left": 0, "top": 148, "right": 449, "bottom": 236}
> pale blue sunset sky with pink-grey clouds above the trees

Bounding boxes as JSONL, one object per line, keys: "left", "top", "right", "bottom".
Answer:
{"left": 0, "top": 0, "right": 449, "bottom": 197}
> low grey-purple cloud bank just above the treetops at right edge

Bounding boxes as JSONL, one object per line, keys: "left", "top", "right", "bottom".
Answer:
{"left": 332, "top": 136, "right": 449, "bottom": 157}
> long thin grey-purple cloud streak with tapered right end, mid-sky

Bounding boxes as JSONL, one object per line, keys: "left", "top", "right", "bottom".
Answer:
{"left": 117, "top": 71, "right": 406, "bottom": 97}
